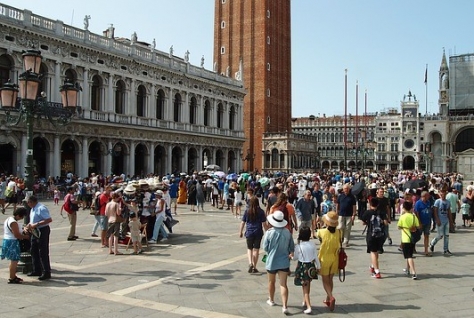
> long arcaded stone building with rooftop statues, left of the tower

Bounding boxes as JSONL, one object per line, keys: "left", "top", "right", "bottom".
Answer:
{"left": 0, "top": 6, "right": 245, "bottom": 177}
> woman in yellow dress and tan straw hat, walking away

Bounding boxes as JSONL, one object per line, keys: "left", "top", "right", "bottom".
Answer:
{"left": 318, "top": 211, "right": 341, "bottom": 311}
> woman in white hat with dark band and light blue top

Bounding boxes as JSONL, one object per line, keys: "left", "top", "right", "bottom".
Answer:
{"left": 263, "top": 210, "right": 295, "bottom": 314}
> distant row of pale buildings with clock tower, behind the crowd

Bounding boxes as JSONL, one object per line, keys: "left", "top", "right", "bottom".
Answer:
{"left": 293, "top": 52, "right": 474, "bottom": 180}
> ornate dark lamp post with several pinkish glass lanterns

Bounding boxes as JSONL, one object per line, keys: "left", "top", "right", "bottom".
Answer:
{"left": 0, "top": 49, "right": 81, "bottom": 191}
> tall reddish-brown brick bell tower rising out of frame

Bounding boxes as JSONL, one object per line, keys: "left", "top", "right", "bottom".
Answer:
{"left": 214, "top": 0, "right": 291, "bottom": 171}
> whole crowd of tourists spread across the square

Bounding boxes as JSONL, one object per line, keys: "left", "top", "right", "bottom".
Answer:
{"left": 0, "top": 171, "right": 474, "bottom": 314}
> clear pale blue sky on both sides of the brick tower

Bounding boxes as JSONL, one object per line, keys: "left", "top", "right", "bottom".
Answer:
{"left": 4, "top": 0, "right": 474, "bottom": 117}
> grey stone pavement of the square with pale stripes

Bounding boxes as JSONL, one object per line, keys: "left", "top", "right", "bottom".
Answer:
{"left": 0, "top": 200, "right": 474, "bottom": 318}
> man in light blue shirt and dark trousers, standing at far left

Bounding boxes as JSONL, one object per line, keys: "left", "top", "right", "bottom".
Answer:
{"left": 26, "top": 195, "right": 53, "bottom": 280}
